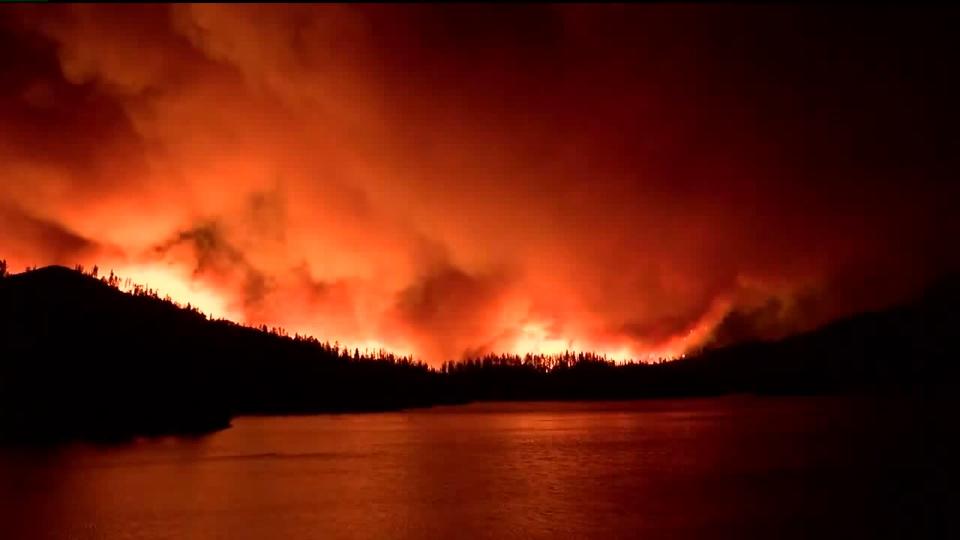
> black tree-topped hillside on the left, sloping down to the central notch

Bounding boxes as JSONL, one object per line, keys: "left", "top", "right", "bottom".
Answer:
{"left": 0, "top": 266, "right": 436, "bottom": 438}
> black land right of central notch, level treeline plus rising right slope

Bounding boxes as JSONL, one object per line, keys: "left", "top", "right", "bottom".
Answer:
{"left": 442, "top": 277, "right": 960, "bottom": 400}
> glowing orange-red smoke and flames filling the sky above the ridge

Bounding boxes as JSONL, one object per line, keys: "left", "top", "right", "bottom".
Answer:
{"left": 0, "top": 5, "right": 960, "bottom": 362}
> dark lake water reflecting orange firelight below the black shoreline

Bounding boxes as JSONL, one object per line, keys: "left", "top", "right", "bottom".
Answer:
{"left": 0, "top": 397, "right": 960, "bottom": 539}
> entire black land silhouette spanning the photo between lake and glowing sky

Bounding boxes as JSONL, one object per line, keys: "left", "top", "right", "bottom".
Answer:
{"left": 0, "top": 266, "right": 960, "bottom": 439}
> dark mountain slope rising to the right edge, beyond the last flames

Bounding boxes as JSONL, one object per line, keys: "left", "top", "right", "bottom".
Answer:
{"left": 676, "top": 276, "right": 960, "bottom": 393}
